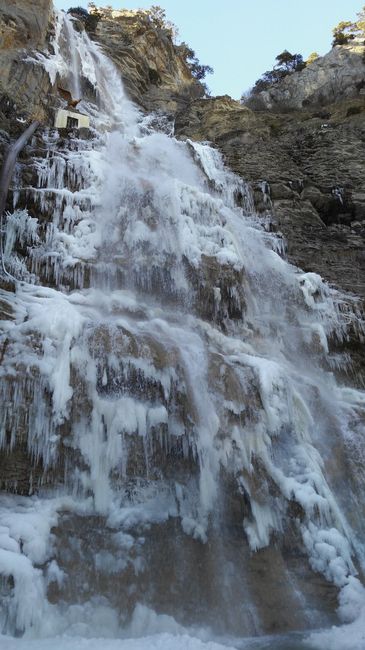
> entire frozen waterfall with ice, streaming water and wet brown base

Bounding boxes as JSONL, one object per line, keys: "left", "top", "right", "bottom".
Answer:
{"left": 0, "top": 14, "right": 365, "bottom": 650}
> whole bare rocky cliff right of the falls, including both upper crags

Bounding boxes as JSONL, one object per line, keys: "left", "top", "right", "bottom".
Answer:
{"left": 86, "top": 11, "right": 365, "bottom": 308}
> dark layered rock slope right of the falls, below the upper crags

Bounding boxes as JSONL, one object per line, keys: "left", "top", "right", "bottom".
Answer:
{"left": 176, "top": 97, "right": 365, "bottom": 304}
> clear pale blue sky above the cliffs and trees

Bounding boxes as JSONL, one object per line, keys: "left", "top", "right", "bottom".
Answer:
{"left": 54, "top": 0, "right": 364, "bottom": 99}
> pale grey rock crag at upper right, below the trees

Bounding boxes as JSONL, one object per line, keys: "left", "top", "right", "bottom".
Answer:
{"left": 252, "top": 39, "right": 365, "bottom": 111}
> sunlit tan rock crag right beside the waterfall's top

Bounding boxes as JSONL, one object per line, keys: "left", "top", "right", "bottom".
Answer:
{"left": 87, "top": 9, "right": 205, "bottom": 113}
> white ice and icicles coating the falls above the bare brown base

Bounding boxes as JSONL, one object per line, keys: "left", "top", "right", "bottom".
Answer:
{"left": 0, "top": 8, "right": 365, "bottom": 635}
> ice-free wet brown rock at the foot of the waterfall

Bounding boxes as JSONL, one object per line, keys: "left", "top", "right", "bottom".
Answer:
{"left": 48, "top": 506, "right": 337, "bottom": 636}
